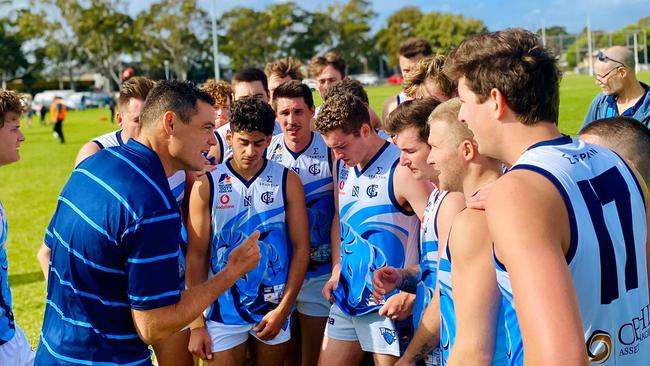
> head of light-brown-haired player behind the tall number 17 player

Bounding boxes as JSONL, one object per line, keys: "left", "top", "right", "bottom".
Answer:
{"left": 404, "top": 55, "right": 458, "bottom": 102}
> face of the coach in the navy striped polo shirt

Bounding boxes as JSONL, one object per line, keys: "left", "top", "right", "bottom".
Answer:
{"left": 169, "top": 100, "right": 217, "bottom": 171}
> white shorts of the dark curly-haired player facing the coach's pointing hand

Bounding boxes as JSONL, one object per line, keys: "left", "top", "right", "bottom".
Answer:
{"left": 205, "top": 317, "right": 291, "bottom": 352}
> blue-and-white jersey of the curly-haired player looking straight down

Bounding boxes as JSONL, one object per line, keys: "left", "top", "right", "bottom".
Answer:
{"left": 333, "top": 142, "right": 420, "bottom": 316}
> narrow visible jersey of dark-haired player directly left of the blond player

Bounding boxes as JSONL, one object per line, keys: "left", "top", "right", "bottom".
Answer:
{"left": 413, "top": 192, "right": 448, "bottom": 329}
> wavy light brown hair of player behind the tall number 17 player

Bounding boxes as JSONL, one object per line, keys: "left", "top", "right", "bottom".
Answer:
{"left": 404, "top": 55, "right": 456, "bottom": 98}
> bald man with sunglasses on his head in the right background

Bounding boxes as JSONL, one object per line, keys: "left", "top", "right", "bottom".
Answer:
{"left": 581, "top": 46, "right": 650, "bottom": 129}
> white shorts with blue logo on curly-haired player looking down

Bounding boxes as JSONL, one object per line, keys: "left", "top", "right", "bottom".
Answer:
{"left": 325, "top": 304, "right": 400, "bottom": 357}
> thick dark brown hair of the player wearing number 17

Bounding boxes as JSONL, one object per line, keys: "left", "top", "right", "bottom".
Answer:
{"left": 444, "top": 29, "right": 562, "bottom": 125}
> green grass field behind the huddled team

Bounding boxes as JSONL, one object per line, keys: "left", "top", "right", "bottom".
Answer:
{"left": 0, "top": 73, "right": 650, "bottom": 345}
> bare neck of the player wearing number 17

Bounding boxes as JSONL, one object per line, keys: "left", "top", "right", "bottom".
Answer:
{"left": 493, "top": 122, "right": 562, "bottom": 166}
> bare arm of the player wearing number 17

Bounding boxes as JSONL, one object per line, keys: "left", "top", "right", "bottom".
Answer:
{"left": 486, "top": 170, "right": 587, "bottom": 365}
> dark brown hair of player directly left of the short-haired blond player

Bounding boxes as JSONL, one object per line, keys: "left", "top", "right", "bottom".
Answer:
{"left": 385, "top": 98, "right": 440, "bottom": 143}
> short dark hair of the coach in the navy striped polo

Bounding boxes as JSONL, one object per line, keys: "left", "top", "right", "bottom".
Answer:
{"left": 140, "top": 80, "right": 214, "bottom": 127}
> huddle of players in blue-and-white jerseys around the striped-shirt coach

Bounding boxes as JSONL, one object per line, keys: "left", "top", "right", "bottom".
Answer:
{"left": 0, "top": 29, "right": 650, "bottom": 366}
